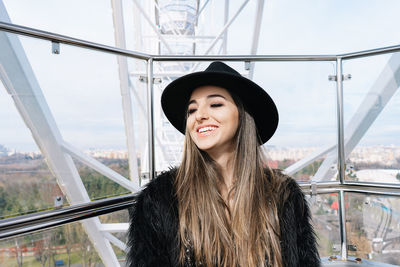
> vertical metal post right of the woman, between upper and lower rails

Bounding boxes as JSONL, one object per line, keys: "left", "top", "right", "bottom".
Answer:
{"left": 336, "top": 57, "right": 345, "bottom": 184}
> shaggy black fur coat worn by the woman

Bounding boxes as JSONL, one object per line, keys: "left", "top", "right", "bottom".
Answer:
{"left": 127, "top": 169, "right": 320, "bottom": 267}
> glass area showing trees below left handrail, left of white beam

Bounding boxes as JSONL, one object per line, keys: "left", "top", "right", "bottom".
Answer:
{"left": 0, "top": 220, "right": 109, "bottom": 267}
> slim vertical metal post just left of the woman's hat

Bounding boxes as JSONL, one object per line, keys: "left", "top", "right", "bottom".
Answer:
{"left": 147, "top": 58, "right": 155, "bottom": 180}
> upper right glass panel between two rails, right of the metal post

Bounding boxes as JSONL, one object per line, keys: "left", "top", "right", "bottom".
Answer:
{"left": 343, "top": 53, "right": 400, "bottom": 183}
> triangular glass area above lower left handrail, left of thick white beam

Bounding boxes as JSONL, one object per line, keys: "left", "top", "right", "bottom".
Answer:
{"left": 0, "top": 40, "right": 63, "bottom": 219}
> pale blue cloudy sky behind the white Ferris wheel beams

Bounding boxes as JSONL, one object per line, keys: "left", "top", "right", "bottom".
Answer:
{"left": 0, "top": 0, "right": 400, "bottom": 151}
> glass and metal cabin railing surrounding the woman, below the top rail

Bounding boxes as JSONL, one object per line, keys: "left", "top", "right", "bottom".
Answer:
{"left": 0, "top": 21, "right": 400, "bottom": 266}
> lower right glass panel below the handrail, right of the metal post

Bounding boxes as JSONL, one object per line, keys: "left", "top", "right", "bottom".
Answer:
{"left": 345, "top": 193, "right": 400, "bottom": 265}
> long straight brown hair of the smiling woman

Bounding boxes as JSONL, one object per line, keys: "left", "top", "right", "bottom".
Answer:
{"left": 175, "top": 95, "right": 282, "bottom": 267}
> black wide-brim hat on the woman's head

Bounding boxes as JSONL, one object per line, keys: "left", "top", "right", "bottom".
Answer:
{"left": 161, "top": 62, "right": 279, "bottom": 144}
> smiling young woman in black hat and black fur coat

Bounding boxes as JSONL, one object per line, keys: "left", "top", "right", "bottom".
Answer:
{"left": 127, "top": 62, "right": 320, "bottom": 267}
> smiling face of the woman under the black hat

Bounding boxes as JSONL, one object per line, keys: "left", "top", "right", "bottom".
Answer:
{"left": 186, "top": 85, "right": 239, "bottom": 157}
